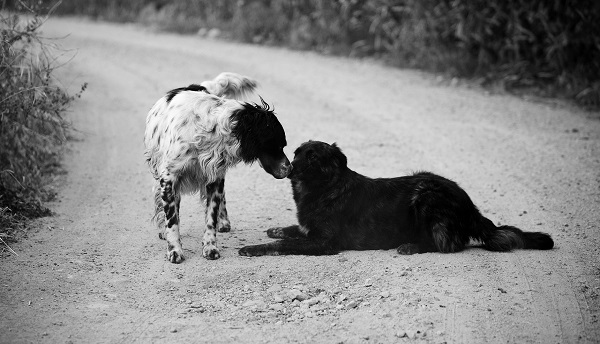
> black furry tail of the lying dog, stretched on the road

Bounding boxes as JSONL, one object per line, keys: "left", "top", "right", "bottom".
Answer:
{"left": 478, "top": 216, "right": 554, "bottom": 251}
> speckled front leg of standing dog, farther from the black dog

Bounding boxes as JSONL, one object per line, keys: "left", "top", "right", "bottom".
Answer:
{"left": 160, "top": 172, "right": 184, "bottom": 263}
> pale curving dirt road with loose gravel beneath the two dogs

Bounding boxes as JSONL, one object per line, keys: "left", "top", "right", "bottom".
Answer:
{"left": 0, "top": 19, "right": 600, "bottom": 343}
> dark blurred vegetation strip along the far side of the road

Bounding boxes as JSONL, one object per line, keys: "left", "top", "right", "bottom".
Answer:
{"left": 42, "top": 0, "right": 600, "bottom": 109}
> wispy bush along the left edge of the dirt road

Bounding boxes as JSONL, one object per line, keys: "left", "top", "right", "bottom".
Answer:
{"left": 0, "top": 2, "right": 85, "bottom": 247}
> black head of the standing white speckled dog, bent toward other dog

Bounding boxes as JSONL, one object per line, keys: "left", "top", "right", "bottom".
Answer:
{"left": 232, "top": 98, "right": 292, "bottom": 179}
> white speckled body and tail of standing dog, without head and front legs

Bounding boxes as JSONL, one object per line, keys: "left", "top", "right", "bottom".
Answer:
{"left": 144, "top": 73, "right": 257, "bottom": 231}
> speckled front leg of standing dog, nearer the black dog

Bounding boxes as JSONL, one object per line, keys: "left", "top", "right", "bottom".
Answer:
{"left": 202, "top": 179, "right": 223, "bottom": 259}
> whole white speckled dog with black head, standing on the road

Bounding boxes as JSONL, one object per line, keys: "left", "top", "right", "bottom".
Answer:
{"left": 144, "top": 73, "right": 291, "bottom": 263}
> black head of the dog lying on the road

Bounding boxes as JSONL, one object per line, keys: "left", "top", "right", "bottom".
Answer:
{"left": 288, "top": 141, "right": 348, "bottom": 183}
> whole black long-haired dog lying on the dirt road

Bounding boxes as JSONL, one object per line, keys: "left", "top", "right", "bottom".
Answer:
{"left": 239, "top": 141, "right": 554, "bottom": 256}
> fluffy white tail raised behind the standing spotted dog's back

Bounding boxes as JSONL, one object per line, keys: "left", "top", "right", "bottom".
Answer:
{"left": 201, "top": 72, "right": 258, "bottom": 100}
